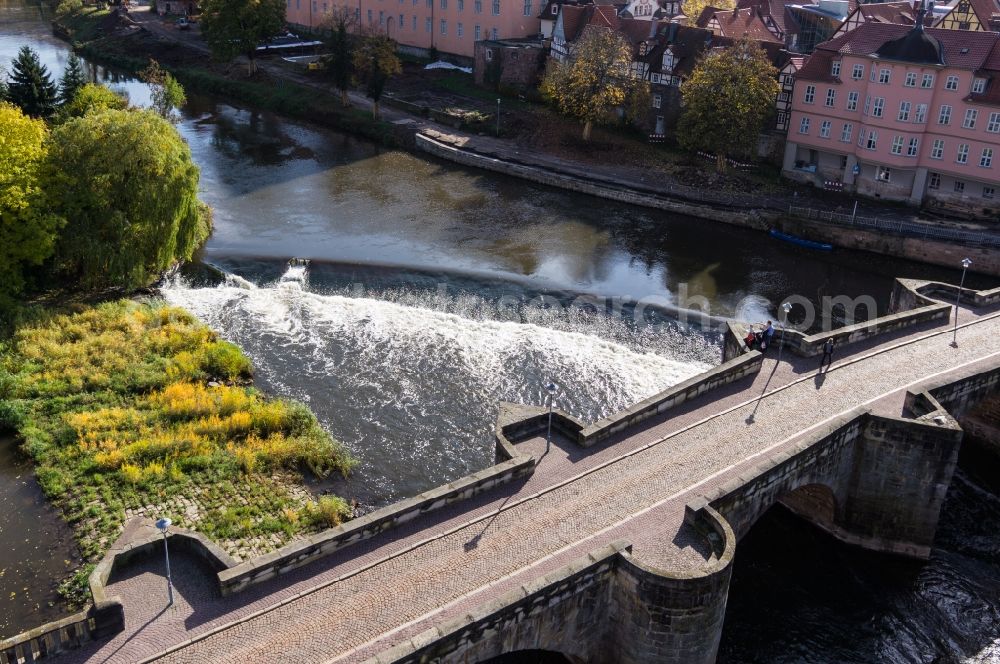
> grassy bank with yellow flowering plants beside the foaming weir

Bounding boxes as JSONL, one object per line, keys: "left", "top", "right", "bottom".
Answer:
{"left": 0, "top": 300, "right": 354, "bottom": 608}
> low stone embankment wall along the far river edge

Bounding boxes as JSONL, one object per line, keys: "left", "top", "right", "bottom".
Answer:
{"left": 416, "top": 134, "right": 1000, "bottom": 276}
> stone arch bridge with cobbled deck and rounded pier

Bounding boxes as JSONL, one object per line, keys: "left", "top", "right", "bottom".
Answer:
{"left": 0, "top": 280, "right": 1000, "bottom": 664}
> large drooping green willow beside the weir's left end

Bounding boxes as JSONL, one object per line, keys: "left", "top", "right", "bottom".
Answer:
{"left": 42, "top": 110, "right": 210, "bottom": 288}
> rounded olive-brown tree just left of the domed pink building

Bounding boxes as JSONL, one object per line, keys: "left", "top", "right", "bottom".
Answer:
{"left": 677, "top": 38, "right": 780, "bottom": 173}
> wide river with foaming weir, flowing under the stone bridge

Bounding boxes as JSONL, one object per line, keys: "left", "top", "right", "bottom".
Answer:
{"left": 0, "top": 0, "right": 1000, "bottom": 662}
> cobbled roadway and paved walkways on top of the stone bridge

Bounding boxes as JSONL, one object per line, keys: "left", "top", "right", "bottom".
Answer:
{"left": 37, "top": 286, "right": 1000, "bottom": 662}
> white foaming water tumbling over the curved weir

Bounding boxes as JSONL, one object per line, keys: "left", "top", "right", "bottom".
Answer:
{"left": 163, "top": 266, "right": 709, "bottom": 502}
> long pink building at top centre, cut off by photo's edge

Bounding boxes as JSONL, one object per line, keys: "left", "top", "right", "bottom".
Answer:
{"left": 285, "top": 0, "right": 544, "bottom": 61}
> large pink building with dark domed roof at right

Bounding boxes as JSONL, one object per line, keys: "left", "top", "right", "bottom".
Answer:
{"left": 783, "top": 12, "right": 1000, "bottom": 214}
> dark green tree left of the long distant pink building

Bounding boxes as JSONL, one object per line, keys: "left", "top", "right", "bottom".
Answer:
{"left": 201, "top": 0, "right": 285, "bottom": 76}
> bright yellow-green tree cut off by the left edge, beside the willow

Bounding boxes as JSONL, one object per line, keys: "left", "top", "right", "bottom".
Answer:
{"left": 0, "top": 102, "right": 59, "bottom": 310}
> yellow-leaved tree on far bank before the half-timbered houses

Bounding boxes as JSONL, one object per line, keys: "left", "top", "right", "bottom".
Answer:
{"left": 541, "top": 27, "right": 649, "bottom": 141}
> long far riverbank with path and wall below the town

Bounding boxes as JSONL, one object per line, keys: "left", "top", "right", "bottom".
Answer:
{"left": 50, "top": 4, "right": 1000, "bottom": 276}
